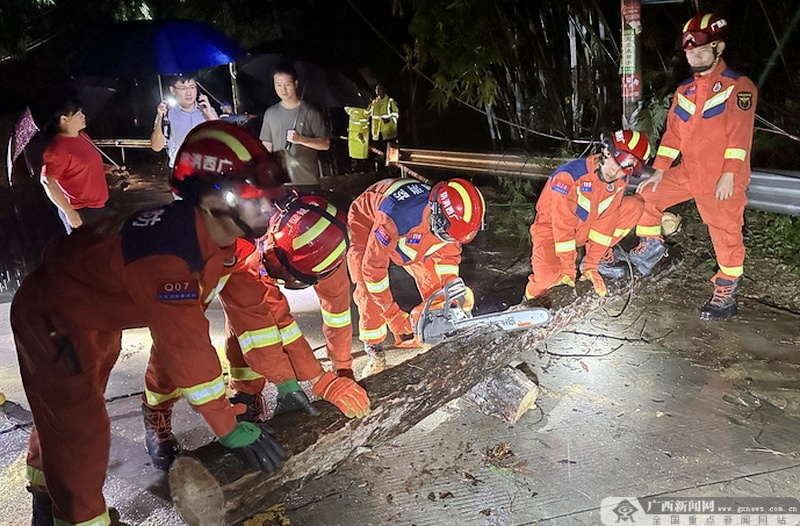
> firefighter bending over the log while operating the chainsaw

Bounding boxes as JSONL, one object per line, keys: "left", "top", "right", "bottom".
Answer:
{"left": 347, "top": 179, "right": 486, "bottom": 373}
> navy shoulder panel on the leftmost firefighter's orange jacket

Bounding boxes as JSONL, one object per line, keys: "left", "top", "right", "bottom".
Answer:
{"left": 122, "top": 201, "right": 205, "bottom": 272}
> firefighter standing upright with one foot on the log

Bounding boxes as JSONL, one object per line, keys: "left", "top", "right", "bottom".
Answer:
{"left": 628, "top": 13, "right": 758, "bottom": 320}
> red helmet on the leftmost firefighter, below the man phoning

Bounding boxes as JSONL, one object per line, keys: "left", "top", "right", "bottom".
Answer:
{"left": 170, "top": 121, "right": 289, "bottom": 199}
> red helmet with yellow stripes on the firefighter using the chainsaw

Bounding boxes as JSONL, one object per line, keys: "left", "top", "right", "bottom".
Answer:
{"left": 429, "top": 179, "right": 486, "bottom": 243}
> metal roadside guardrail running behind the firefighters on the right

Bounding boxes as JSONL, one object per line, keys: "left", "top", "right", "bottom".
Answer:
{"left": 386, "top": 144, "right": 800, "bottom": 216}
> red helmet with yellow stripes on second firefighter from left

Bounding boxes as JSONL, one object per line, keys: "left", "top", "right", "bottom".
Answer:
{"left": 265, "top": 194, "right": 349, "bottom": 285}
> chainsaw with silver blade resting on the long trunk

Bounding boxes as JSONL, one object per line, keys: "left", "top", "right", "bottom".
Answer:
{"left": 414, "top": 278, "right": 553, "bottom": 344}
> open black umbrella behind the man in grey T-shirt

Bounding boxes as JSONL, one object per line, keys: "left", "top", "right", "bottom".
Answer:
{"left": 239, "top": 53, "right": 370, "bottom": 108}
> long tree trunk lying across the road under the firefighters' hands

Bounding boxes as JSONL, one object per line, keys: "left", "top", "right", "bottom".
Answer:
{"left": 169, "top": 251, "right": 676, "bottom": 526}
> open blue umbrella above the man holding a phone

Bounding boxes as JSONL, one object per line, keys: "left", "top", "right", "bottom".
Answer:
{"left": 73, "top": 20, "right": 245, "bottom": 77}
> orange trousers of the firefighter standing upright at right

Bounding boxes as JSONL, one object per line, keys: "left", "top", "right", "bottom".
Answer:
{"left": 636, "top": 169, "right": 747, "bottom": 280}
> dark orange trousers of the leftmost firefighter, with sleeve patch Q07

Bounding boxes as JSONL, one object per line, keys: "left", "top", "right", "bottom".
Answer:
{"left": 11, "top": 271, "right": 122, "bottom": 524}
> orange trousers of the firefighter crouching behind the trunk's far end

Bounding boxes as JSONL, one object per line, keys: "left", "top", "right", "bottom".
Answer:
{"left": 525, "top": 197, "right": 644, "bottom": 298}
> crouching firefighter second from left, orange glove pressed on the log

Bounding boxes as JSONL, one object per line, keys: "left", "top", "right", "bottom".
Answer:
{"left": 142, "top": 193, "right": 369, "bottom": 470}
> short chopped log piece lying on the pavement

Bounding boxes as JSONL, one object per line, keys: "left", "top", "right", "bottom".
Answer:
{"left": 464, "top": 366, "right": 539, "bottom": 424}
